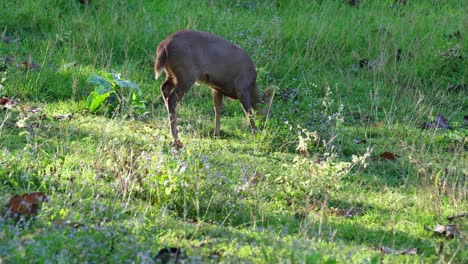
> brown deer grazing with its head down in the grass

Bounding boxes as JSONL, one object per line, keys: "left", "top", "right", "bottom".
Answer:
{"left": 154, "top": 30, "right": 259, "bottom": 146}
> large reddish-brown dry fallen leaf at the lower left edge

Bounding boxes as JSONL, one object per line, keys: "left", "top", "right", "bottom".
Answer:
{"left": 6, "top": 192, "right": 47, "bottom": 219}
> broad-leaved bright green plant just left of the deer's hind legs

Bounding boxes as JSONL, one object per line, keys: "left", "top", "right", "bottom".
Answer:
{"left": 86, "top": 71, "right": 146, "bottom": 115}
